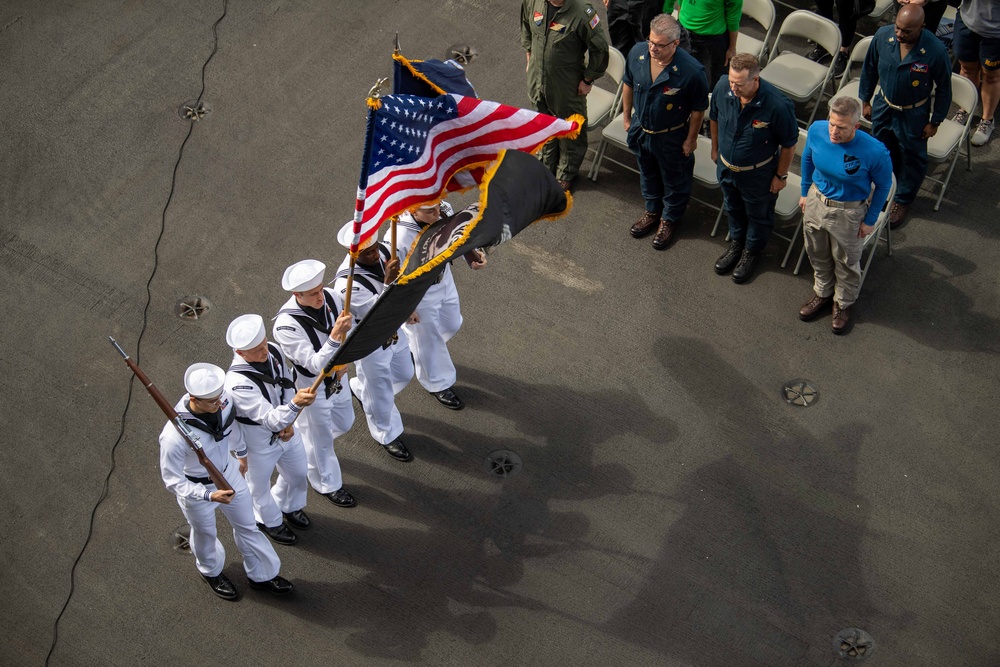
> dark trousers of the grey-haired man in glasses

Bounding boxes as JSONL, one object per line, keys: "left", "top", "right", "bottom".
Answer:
{"left": 629, "top": 125, "right": 694, "bottom": 222}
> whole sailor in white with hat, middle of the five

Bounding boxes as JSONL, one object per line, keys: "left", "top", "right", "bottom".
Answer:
{"left": 271, "top": 259, "right": 355, "bottom": 507}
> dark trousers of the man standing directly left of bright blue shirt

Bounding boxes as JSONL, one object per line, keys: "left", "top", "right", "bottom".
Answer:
{"left": 718, "top": 166, "right": 778, "bottom": 252}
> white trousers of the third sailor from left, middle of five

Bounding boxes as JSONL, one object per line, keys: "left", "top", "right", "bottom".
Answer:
{"left": 295, "top": 386, "right": 354, "bottom": 493}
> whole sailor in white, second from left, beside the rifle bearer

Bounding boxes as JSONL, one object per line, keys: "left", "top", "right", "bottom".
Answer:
{"left": 226, "top": 315, "right": 316, "bottom": 545}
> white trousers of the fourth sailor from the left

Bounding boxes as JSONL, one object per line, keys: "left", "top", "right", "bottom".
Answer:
{"left": 351, "top": 333, "right": 413, "bottom": 445}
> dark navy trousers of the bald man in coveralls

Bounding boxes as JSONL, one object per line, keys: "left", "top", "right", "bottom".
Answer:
{"left": 872, "top": 100, "right": 930, "bottom": 204}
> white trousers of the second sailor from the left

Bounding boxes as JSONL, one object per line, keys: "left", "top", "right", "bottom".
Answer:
{"left": 246, "top": 436, "right": 308, "bottom": 528}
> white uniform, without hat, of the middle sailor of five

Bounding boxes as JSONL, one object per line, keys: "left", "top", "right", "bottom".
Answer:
{"left": 272, "top": 289, "right": 354, "bottom": 494}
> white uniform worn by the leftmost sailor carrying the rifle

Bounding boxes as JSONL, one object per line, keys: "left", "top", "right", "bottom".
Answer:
{"left": 160, "top": 392, "right": 281, "bottom": 582}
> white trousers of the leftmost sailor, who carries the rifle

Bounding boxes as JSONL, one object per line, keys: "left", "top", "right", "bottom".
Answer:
{"left": 177, "top": 459, "right": 281, "bottom": 581}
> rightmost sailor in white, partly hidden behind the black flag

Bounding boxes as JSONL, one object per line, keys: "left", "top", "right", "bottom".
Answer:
{"left": 385, "top": 201, "right": 486, "bottom": 410}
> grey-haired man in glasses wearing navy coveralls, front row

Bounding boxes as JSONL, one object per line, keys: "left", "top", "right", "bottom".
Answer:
{"left": 622, "top": 14, "right": 708, "bottom": 250}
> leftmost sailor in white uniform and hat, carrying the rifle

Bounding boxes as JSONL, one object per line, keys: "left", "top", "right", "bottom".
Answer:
{"left": 160, "top": 363, "right": 292, "bottom": 600}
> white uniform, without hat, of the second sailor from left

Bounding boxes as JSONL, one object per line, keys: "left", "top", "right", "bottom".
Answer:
{"left": 225, "top": 343, "right": 308, "bottom": 528}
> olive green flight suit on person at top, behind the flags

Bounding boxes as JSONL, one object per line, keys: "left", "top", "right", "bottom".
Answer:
{"left": 521, "top": 0, "right": 608, "bottom": 181}
